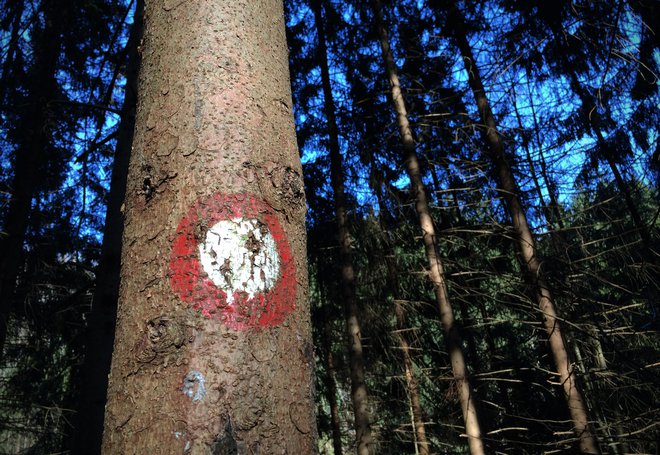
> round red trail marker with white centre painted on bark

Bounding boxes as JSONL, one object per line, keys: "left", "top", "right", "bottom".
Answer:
{"left": 170, "top": 193, "right": 296, "bottom": 330}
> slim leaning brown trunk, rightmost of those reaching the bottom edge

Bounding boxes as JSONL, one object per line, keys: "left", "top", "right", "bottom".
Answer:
{"left": 450, "top": 9, "right": 600, "bottom": 453}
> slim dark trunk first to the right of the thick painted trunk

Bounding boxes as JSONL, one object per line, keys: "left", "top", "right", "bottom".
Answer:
{"left": 311, "top": 0, "right": 373, "bottom": 455}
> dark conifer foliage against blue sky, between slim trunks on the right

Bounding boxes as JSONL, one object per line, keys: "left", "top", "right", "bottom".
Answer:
{"left": 290, "top": 1, "right": 659, "bottom": 454}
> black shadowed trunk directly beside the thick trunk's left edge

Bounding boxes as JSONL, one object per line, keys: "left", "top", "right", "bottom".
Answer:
{"left": 73, "top": 0, "right": 144, "bottom": 455}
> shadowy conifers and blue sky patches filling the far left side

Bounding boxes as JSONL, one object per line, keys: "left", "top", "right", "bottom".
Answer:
{"left": 0, "top": 0, "right": 131, "bottom": 454}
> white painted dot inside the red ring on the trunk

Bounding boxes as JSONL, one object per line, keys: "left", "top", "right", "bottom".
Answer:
{"left": 199, "top": 218, "right": 280, "bottom": 305}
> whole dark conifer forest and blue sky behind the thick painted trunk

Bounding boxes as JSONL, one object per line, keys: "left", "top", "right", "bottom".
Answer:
{"left": 0, "top": 0, "right": 660, "bottom": 455}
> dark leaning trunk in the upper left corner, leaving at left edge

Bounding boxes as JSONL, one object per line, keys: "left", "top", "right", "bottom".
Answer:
{"left": 0, "top": 0, "right": 65, "bottom": 360}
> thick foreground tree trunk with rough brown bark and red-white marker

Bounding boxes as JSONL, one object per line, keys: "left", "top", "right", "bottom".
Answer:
{"left": 103, "top": 0, "right": 316, "bottom": 454}
